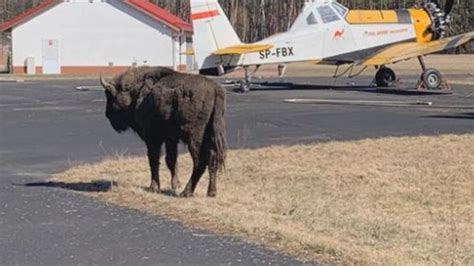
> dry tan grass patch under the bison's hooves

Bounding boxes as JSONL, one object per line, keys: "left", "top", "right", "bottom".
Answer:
{"left": 52, "top": 135, "right": 474, "bottom": 265}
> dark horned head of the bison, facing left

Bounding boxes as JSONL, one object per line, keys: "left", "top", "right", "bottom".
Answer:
{"left": 100, "top": 77, "right": 134, "bottom": 133}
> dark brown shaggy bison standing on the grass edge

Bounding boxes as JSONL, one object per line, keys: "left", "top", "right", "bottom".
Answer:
{"left": 100, "top": 67, "right": 226, "bottom": 197}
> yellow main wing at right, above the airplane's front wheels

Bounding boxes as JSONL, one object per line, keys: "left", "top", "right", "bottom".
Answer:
{"left": 360, "top": 31, "right": 474, "bottom": 66}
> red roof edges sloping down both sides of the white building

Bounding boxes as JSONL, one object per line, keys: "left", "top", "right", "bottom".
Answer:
{"left": 0, "top": 0, "right": 193, "bottom": 33}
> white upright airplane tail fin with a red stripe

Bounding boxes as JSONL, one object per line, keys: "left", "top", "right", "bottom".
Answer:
{"left": 191, "top": 0, "right": 242, "bottom": 75}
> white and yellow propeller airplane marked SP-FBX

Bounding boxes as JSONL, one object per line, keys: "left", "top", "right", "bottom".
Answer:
{"left": 191, "top": 0, "right": 474, "bottom": 92}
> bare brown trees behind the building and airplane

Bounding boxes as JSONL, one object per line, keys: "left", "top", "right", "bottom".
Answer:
{"left": 0, "top": 0, "right": 474, "bottom": 52}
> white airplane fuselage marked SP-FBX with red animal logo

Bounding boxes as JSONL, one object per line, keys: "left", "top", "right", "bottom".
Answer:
{"left": 223, "top": 9, "right": 431, "bottom": 66}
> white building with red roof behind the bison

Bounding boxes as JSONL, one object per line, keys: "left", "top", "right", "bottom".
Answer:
{"left": 0, "top": 0, "right": 193, "bottom": 74}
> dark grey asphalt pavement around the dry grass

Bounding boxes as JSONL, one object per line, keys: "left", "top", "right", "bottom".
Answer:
{"left": 0, "top": 78, "right": 474, "bottom": 265}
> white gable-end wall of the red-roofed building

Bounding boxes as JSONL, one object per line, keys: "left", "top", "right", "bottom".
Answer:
{"left": 12, "top": 0, "right": 184, "bottom": 73}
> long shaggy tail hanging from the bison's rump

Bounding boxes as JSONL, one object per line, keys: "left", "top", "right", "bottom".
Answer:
{"left": 209, "top": 88, "right": 227, "bottom": 170}
